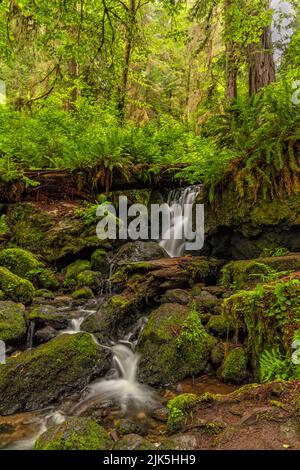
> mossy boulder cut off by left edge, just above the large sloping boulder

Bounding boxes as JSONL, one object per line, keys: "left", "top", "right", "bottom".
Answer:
{"left": 0, "top": 301, "right": 27, "bottom": 344}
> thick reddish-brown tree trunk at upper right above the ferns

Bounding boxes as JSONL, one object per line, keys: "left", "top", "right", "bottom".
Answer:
{"left": 248, "top": 26, "right": 276, "bottom": 96}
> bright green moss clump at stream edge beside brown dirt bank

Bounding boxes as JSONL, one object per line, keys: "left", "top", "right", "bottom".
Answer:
{"left": 167, "top": 393, "right": 199, "bottom": 432}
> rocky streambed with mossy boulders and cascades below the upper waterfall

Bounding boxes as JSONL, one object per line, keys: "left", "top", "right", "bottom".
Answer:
{"left": 0, "top": 197, "right": 300, "bottom": 450}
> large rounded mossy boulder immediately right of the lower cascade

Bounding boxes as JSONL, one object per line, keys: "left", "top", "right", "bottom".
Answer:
{"left": 137, "top": 304, "right": 216, "bottom": 384}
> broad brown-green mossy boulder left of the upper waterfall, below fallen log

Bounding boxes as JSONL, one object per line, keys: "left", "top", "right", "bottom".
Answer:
{"left": 6, "top": 201, "right": 107, "bottom": 262}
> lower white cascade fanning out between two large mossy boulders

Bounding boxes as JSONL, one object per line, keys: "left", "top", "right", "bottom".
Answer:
{"left": 73, "top": 344, "right": 157, "bottom": 415}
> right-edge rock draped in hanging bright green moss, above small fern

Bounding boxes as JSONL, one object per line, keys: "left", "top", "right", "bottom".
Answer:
{"left": 222, "top": 277, "right": 300, "bottom": 369}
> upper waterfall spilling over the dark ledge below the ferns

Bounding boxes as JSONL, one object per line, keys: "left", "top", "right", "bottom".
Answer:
{"left": 159, "top": 186, "right": 201, "bottom": 258}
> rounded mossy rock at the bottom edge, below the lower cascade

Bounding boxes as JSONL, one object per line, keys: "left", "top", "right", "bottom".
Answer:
{"left": 34, "top": 418, "right": 113, "bottom": 450}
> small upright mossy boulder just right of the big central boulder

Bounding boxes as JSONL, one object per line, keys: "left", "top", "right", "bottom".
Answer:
{"left": 219, "top": 347, "right": 249, "bottom": 384}
